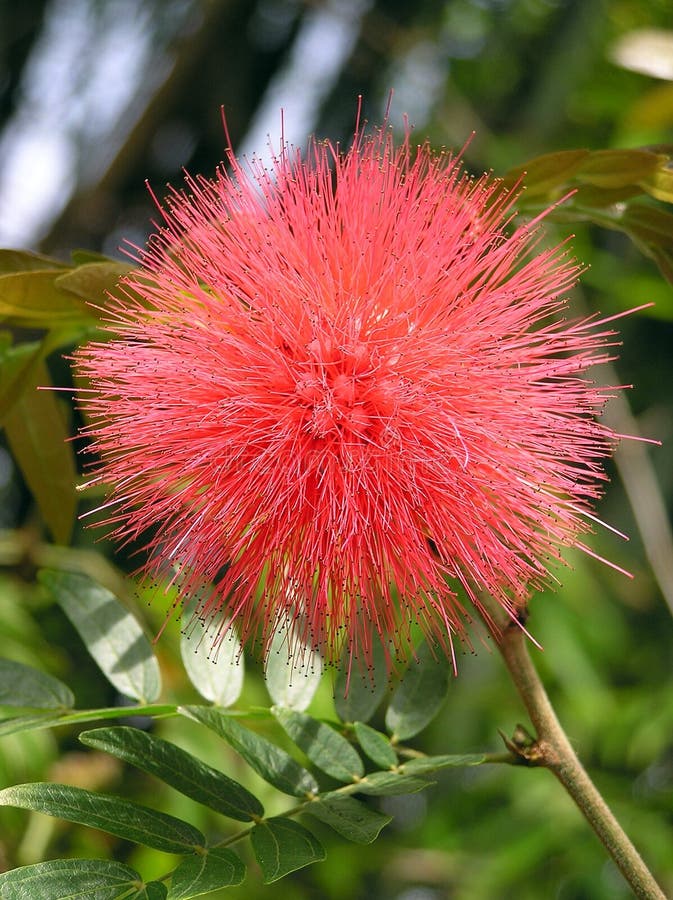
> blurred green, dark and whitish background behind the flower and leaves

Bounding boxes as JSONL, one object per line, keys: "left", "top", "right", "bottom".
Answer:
{"left": 0, "top": 0, "right": 673, "bottom": 900}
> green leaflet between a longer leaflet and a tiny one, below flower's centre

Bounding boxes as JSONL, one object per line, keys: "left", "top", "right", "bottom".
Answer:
{"left": 271, "top": 706, "right": 365, "bottom": 782}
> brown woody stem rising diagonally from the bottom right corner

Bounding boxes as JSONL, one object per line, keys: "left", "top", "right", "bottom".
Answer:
{"left": 486, "top": 619, "right": 666, "bottom": 900}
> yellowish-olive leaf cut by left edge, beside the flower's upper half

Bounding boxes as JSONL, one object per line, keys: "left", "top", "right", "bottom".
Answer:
{"left": 0, "top": 268, "right": 96, "bottom": 329}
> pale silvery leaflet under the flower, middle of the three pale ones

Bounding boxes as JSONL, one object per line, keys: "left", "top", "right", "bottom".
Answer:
{"left": 180, "top": 604, "right": 244, "bottom": 707}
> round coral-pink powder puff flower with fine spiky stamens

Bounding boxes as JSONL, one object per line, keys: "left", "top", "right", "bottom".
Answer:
{"left": 76, "top": 109, "right": 628, "bottom": 659}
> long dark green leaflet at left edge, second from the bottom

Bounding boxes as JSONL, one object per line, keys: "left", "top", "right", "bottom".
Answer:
{"left": 0, "top": 782, "right": 205, "bottom": 853}
